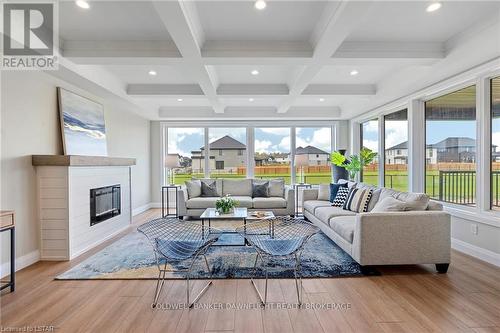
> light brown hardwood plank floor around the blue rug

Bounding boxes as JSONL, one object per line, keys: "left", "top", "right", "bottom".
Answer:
{"left": 0, "top": 209, "right": 500, "bottom": 333}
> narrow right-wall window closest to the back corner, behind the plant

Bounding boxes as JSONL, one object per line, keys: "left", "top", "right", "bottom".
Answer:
{"left": 361, "top": 119, "right": 378, "bottom": 185}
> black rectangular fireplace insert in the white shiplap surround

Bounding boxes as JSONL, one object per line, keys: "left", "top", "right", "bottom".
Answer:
{"left": 90, "top": 185, "right": 121, "bottom": 226}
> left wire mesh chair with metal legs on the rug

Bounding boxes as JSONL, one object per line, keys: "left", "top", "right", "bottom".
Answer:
{"left": 137, "top": 218, "right": 220, "bottom": 308}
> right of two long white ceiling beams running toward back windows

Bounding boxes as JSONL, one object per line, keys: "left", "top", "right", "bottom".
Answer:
{"left": 278, "top": 1, "right": 372, "bottom": 113}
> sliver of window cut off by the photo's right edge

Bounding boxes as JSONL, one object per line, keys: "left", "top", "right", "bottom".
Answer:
{"left": 490, "top": 77, "right": 500, "bottom": 210}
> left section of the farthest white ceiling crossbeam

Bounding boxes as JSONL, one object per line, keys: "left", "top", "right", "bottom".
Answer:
{"left": 127, "top": 84, "right": 204, "bottom": 96}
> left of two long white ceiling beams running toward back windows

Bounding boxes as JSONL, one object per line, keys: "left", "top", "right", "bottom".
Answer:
{"left": 153, "top": 1, "right": 224, "bottom": 113}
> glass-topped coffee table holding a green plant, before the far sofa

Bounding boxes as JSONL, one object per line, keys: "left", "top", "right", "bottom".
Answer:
{"left": 200, "top": 207, "right": 274, "bottom": 246}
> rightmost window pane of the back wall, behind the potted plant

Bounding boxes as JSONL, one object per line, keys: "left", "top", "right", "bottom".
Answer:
{"left": 295, "top": 127, "right": 332, "bottom": 185}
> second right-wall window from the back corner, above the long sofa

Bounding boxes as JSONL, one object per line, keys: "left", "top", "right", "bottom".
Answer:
{"left": 384, "top": 109, "right": 408, "bottom": 191}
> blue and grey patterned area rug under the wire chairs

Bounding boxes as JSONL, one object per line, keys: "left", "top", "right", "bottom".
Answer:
{"left": 56, "top": 228, "right": 372, "bottom": 280}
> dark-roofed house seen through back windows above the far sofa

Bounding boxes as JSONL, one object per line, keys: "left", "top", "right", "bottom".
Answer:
{"left": 191, "top": 135, "right": 246, "bottom": 172}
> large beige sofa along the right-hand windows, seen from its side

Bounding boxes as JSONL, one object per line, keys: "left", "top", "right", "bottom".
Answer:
{"left": 302, "top": 179, "right": 451, "bottom": 273}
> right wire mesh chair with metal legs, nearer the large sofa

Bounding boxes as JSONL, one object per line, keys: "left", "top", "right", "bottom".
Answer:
{"left": 236, "top": 216, "right": 319, "bottom": 305}
